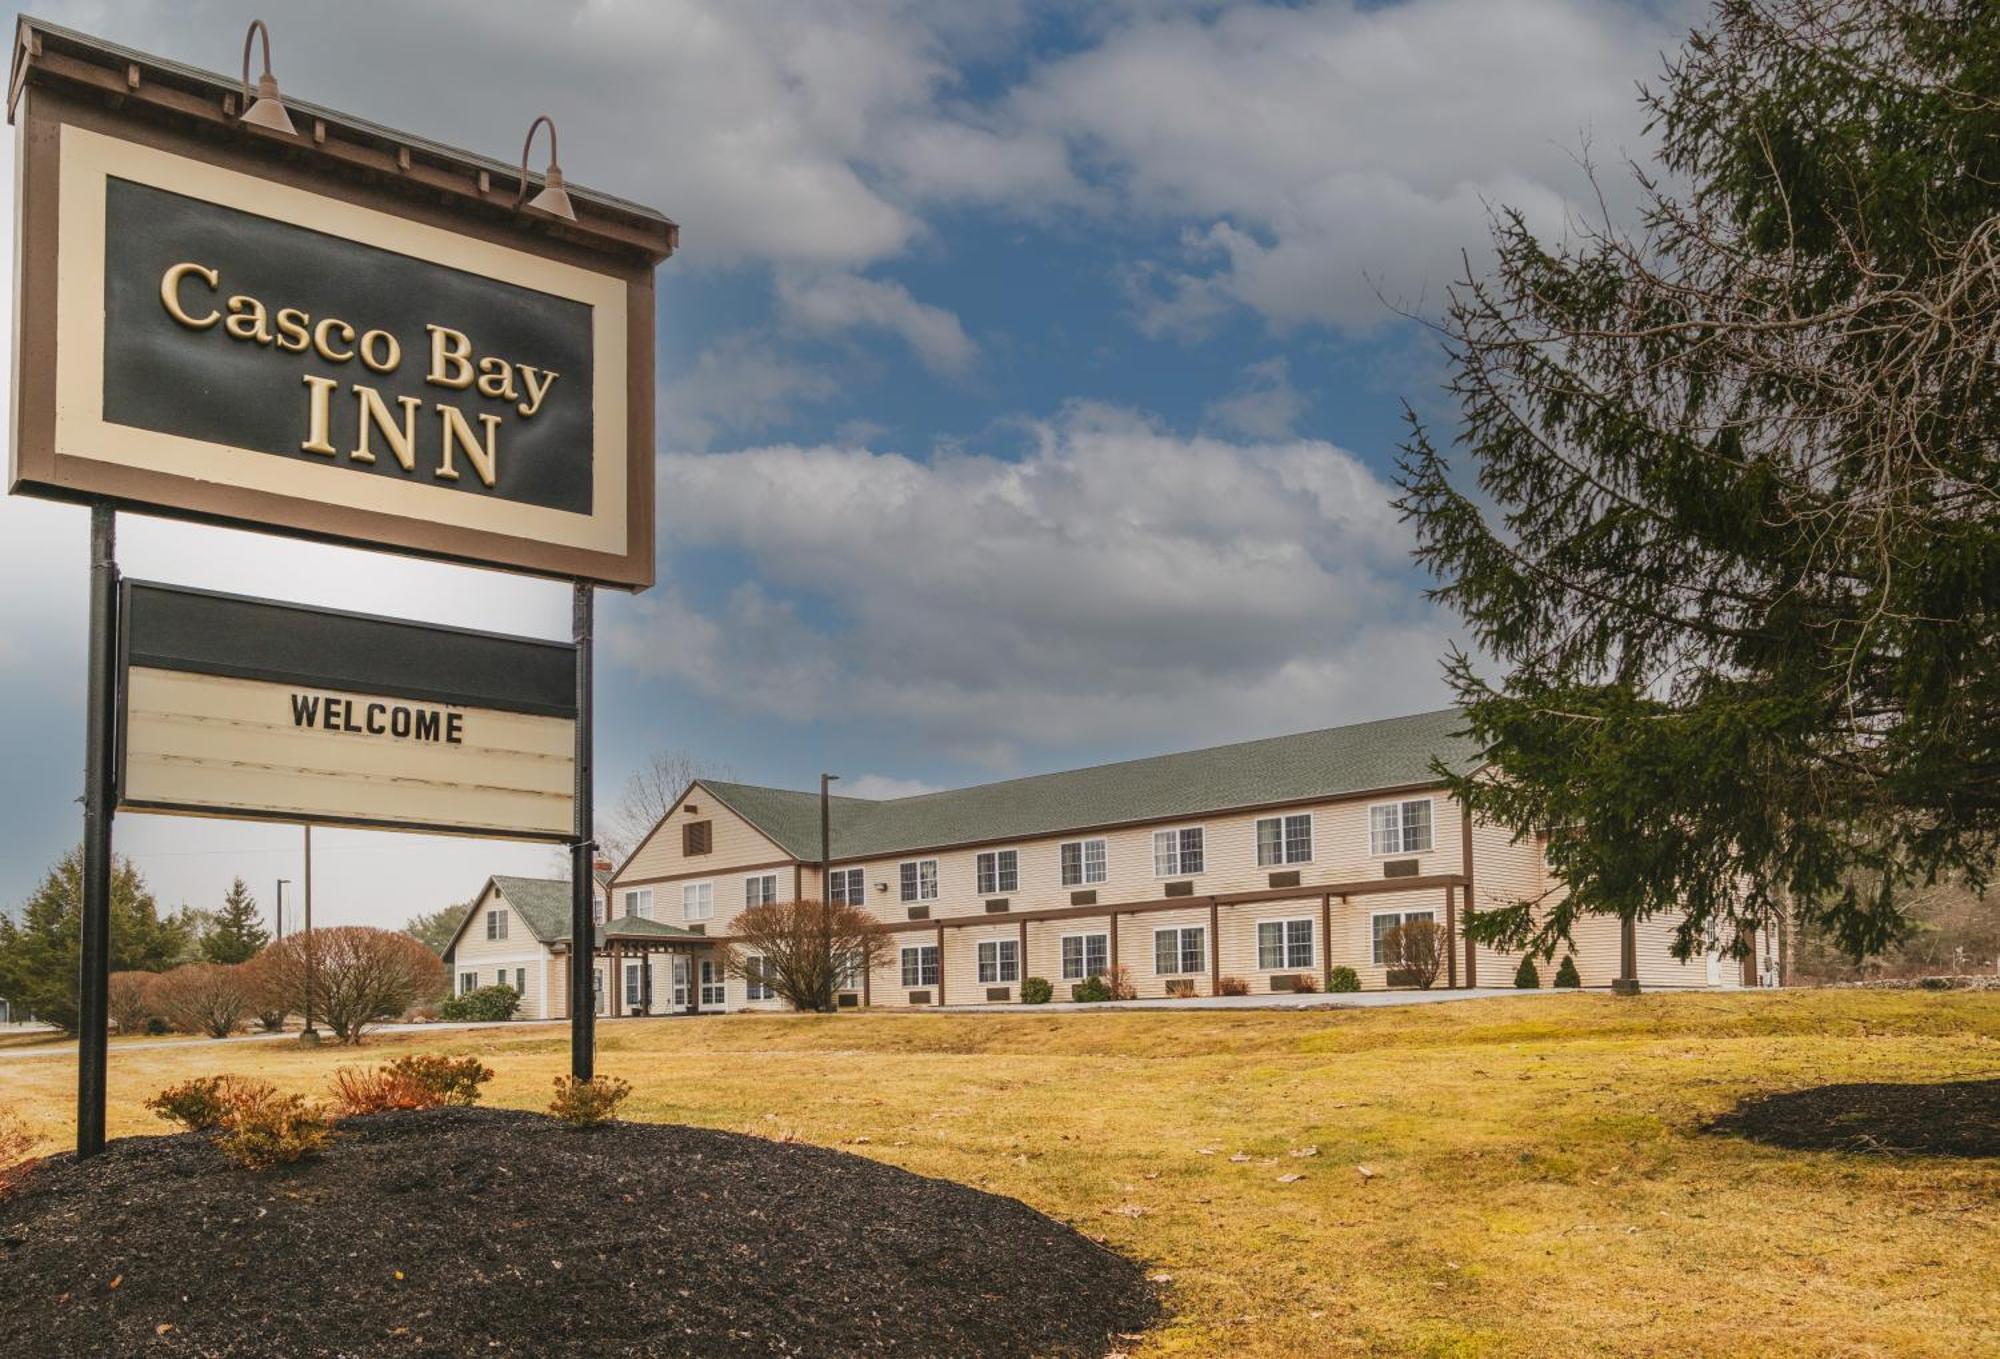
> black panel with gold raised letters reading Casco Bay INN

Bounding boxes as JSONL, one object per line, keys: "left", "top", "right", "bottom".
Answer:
{"left": 104, "top": 178, "right": 592, "bottom": 514}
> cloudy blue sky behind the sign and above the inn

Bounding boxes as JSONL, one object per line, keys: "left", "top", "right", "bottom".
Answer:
{"left": 0, "top": 0, "right": 1700, "bottom": 925}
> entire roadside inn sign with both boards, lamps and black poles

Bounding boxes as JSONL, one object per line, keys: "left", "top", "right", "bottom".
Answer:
{"left": 8, "top": 18, "right": 678, "bottom": 1155}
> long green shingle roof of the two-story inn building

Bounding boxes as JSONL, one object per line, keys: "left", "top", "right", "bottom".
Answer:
{"left": 702, "top": 707, "right": 1480, "bottom": 859}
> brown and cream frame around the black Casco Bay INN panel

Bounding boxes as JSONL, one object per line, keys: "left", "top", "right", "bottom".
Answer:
{"left": 8, "top": 20, "right": 678, "bottom": 590}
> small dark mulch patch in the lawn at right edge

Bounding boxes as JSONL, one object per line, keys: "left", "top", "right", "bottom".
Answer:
{"left": 1710, "top": 1079, "right": 2000, "bottom": 1155}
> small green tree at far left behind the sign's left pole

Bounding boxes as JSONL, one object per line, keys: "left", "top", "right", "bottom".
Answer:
{"left": 0, "top": 847, "right": 188, "bottom": 1033}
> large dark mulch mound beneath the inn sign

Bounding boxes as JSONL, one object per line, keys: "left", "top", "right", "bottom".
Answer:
{"left": 0, "top": 1109, "right": 1158, "bottom": 1359}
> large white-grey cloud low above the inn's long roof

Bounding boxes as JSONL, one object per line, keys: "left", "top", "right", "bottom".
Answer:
{"left": 608, "top": 406, "right": 1444, "bottom": 763}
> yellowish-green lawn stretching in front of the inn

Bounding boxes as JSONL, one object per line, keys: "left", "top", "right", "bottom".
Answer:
{"left": 0, "top": 991, "right": 2000, "bottom": 1357}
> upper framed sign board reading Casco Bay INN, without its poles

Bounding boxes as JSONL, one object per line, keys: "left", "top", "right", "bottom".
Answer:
{"left": 10, "top": 26, "right": 674, "bottom": 588}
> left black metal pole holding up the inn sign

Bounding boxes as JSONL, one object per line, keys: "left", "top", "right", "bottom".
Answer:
{"left": 76, "top": 506, "right": 118, "bottom": 1159}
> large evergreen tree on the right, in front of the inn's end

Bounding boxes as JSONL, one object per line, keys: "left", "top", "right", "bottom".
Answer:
{"left": 1398, "top": 0, "right": 2000, "bottom": 959}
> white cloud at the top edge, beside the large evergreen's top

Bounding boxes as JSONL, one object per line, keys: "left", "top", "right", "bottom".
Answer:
{"left": 1010, "top": 0, "right": 1706, "bottom": 334}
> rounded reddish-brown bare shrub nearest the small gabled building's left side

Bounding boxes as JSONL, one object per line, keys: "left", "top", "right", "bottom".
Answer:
{"left": 258, "top": 925, "right": 444, "bottom": 1043}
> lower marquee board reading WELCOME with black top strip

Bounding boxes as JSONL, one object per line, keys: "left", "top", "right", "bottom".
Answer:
{"left": 116, "top": 582, "right": 576, "bottom": 841}
